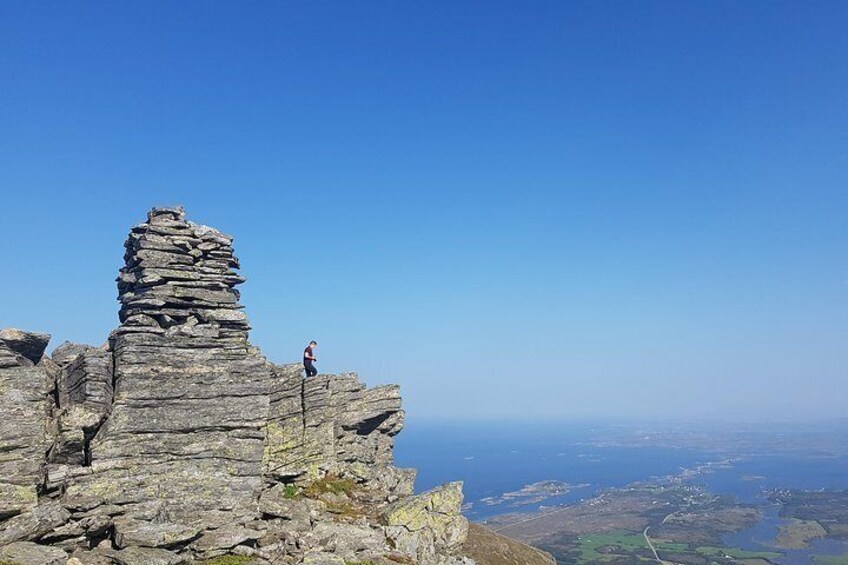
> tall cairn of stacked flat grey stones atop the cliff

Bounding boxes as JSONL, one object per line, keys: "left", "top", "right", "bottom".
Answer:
{"left": 118, "top": 207, "right": 250, "bottom": 340}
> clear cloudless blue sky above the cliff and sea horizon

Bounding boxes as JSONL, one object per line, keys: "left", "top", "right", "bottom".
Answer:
{"left": 0, "top": 0, "right": 848, "bottom": 420}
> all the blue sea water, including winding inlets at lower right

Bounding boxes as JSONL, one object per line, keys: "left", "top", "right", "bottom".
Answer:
{"left": 395, "top": 422, "right": 848, "bottom": 565}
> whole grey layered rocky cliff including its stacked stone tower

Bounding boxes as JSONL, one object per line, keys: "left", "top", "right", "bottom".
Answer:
{"left": 0, "top": 208, "right": 553, "bottom": 565}
